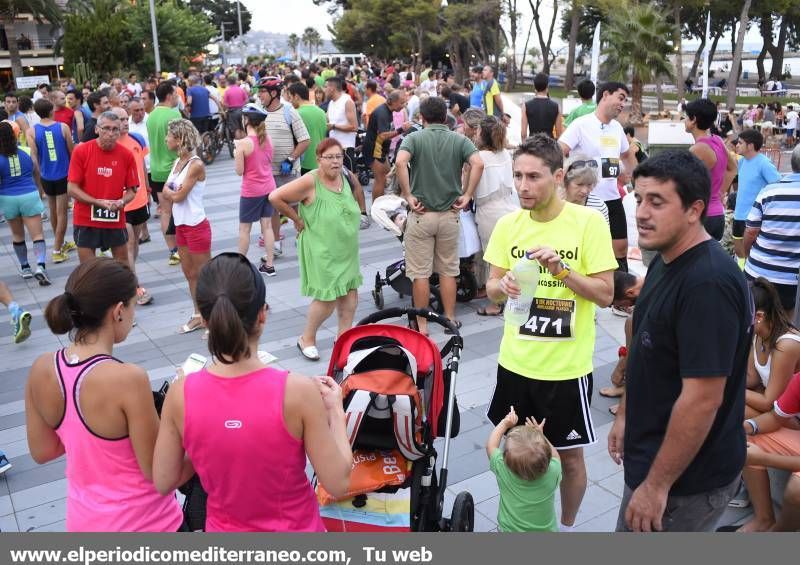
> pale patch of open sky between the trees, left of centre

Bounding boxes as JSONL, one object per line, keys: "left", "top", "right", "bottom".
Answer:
{"left": 241, "top": 0, "right": 331, "bottom": 39}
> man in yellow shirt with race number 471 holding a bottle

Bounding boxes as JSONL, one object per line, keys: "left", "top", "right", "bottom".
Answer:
{"left": 484, "top": 134, "right": 617, "bottom": 529}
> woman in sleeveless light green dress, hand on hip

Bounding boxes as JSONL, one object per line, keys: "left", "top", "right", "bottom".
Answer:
{"left": 269, "top": 138, "right": 362, "bottom": 361}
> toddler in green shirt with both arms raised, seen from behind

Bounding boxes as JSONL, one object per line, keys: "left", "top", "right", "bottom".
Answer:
{"left": 486, "top": 406, "right": 561, "bottom": 532}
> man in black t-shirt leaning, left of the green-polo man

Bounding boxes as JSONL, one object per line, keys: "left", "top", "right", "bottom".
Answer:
{"left": 364, "top": 90, "right": 411, "bottom": 202}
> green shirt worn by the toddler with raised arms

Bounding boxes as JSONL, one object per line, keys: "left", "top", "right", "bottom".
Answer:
{"left": 489, "top": 449, "right": 561, "bottom": 532}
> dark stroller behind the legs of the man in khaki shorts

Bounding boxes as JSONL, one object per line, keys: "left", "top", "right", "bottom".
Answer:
{"left": 371, "top": 194, "right": 479, "bottom": 314}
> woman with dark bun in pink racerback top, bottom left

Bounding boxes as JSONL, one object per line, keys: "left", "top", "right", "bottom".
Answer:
{"left": 25, "top": 258, "right": 184, "bottom": 532}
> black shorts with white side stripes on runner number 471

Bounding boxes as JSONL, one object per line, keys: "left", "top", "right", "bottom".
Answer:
{"left": 487, "top": 365, "right": 597, "bottom": 449}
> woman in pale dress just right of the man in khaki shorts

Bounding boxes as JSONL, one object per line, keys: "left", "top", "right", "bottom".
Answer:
{"left": 468, "top": 115, "right": 519, "bottom": 316}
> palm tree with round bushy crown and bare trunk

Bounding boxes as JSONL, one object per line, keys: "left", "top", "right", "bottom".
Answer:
{"left": 603, "top": 2, "right": 674, "bottom": 123}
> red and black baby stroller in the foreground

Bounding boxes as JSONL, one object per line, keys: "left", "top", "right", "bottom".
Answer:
{"left": 317, "top": 308, "right": 474, "bottom": 532}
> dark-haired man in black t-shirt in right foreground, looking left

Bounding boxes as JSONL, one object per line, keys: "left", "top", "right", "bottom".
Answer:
{"left": 608, "top": 150, "right": 753, "bottom": 531}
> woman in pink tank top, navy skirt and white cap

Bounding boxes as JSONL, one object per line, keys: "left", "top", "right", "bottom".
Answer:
{"left": 233, "top": 104, "right": 276, "bottom": 277}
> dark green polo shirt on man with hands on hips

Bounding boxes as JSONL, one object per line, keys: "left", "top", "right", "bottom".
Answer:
{"left": 399, "top": 124, "right": 478, "bottom": 212}
